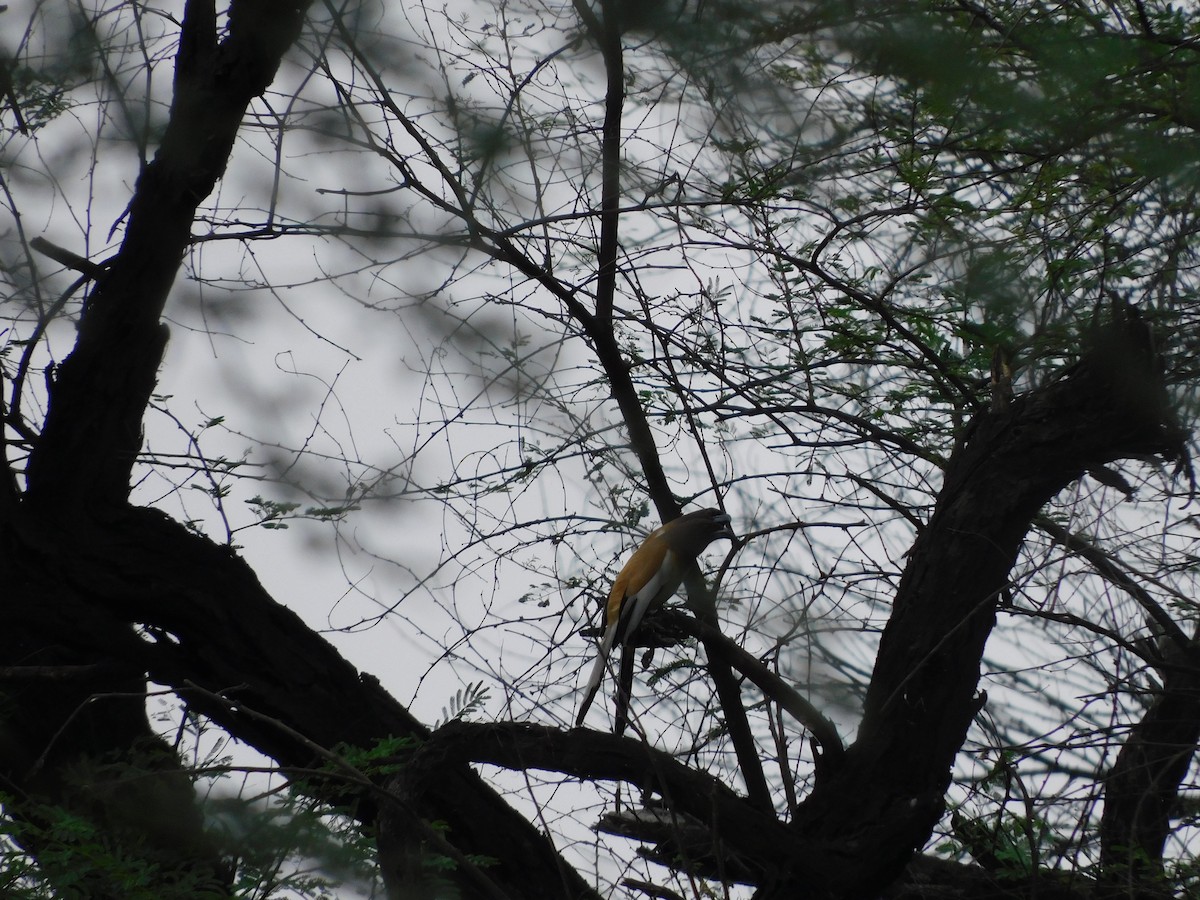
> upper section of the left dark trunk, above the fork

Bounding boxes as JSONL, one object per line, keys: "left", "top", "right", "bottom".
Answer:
{"left": 24, "top": 0, "right": 308, "bottom": 515}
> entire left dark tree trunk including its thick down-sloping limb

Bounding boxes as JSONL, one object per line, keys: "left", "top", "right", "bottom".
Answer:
{"left": 0, "top": 0, "right": 593, "bottom": 898}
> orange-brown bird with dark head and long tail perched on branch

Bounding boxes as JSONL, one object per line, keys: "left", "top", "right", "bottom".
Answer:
{"left": 575, "top": 509, "right": 733, "bottom": 734}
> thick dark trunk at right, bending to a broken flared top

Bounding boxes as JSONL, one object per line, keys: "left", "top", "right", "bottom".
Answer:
{"left": 770, "top": 308, "right": 1184, "bottom": 899}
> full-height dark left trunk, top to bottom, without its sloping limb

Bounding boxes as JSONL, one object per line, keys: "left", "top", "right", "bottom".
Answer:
{"left": 0, "top": 0, "right": 307, "bottom": 898}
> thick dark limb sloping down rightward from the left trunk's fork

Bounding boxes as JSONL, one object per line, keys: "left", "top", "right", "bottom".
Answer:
{"left": 10, "top": 508, "right": 595, "bottom": 898}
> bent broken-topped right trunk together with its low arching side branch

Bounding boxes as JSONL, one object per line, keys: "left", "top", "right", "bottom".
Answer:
{"left": 413, "top": 311, "right": 1180, "bottom": 900}
